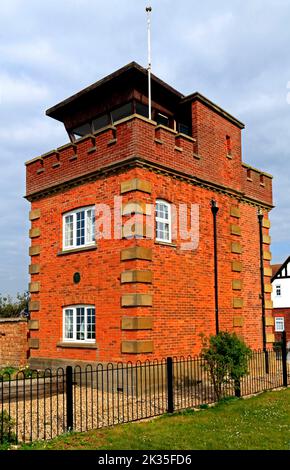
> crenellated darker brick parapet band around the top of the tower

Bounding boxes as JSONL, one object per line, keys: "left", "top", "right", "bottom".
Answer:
{"left": 26, "top": 114, "right": 272, "bottom": 205}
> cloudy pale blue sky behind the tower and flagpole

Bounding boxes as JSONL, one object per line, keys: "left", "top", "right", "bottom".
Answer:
{"left": 0, "top": 0, "right": 290, "bottom": 294}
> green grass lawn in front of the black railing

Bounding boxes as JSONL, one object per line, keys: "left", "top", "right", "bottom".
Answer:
{"left": 22, "top": 389, "right": 290, "bottom": 450}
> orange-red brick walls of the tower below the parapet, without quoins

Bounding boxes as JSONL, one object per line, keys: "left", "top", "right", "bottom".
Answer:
{"left": 31, "top": 163, "right": 271, "bottom": 361}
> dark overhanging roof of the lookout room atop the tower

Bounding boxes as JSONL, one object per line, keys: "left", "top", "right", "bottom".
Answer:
{"left": 46, "top": 62, "right": 244, "bottom": 129}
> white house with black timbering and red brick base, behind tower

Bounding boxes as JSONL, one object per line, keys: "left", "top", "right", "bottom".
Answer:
{"left": 272, "top": 256, "right": 290, "bottom": 343}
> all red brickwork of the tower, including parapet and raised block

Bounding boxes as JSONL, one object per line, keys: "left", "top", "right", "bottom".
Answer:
{"left": 27, "top": 111, "right": 272, "bottom": 368}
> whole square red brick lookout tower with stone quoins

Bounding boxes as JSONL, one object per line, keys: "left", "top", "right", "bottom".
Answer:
{"left": 26, "top": 62, "right": 274, "bottom": 368}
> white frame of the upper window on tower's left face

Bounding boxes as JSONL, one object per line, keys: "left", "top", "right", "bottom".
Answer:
{"left": 62, "top": 206, "right": 96, "bottom": 251}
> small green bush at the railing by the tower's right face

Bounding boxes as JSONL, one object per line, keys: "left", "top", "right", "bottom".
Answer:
{"left": 202, "top": 331, "right": 252, "bottom": 400}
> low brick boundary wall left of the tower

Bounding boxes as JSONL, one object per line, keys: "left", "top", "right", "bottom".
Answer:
{"left": 0, "top": 318, "right": 29, "bottom": 367}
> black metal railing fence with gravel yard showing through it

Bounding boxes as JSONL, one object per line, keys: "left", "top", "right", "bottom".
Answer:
{"left": 0, "top": 339, "right": 290, "bottom": 443}
